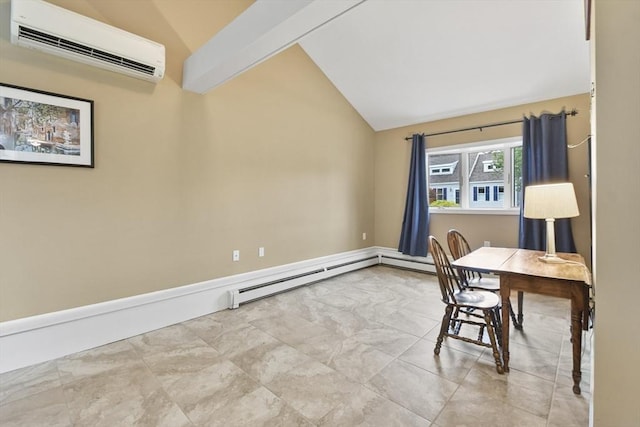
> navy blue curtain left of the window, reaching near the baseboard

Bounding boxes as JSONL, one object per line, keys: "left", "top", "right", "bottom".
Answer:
{"left": 398, "top": 134, "right": 429, "bottom": 256}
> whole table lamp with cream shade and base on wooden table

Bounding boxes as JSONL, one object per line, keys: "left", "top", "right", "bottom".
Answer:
{"left": 524, "top": 182, "right": 580, "bottom": 264}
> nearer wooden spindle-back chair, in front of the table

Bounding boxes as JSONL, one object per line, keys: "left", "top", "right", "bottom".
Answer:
{"left": 429, "top": 236, "right": 504, "bottom": 374}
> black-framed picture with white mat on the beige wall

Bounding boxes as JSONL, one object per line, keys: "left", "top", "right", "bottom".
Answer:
{"left": 0, "top": 83, "right": 93, "bottom": 168}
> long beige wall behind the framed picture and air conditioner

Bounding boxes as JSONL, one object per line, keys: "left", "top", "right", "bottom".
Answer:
{"left": 0, "top": 0, "right": 374, "bottom": 321}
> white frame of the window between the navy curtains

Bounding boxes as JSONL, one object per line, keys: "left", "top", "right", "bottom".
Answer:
{"left": 425, "top": 136, "right": 522, "bottom": 215}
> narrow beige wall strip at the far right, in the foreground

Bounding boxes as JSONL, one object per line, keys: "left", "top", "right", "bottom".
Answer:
{"left": 592, "top": 0, "right": 640, "bottom": 427}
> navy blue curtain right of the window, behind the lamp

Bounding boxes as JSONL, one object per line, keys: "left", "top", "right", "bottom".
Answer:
{"left": 519, "top": 111, "right": 576, "bottom": 252}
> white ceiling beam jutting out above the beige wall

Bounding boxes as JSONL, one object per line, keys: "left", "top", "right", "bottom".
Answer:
{"left": 182, "top": 0, "right": 366, "bottom": 93}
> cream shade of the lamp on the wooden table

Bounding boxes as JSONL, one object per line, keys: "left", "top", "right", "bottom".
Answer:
{"left": 524, "top": 182, "right": 580, "bottom": 219}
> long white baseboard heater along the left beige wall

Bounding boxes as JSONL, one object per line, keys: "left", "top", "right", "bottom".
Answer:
{"left": 229, "top": 255, "right": 380, "bottom": 308}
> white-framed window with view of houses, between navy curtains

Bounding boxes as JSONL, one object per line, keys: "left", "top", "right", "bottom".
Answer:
{"left": 427, "top": 137, "right": 522, "bottom": 213}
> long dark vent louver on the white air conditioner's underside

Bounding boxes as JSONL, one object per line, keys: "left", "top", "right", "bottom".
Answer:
{"left": 18, "top": 25, "right": 156, "bottom": 76}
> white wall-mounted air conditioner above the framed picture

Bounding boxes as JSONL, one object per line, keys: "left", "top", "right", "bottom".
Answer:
{"left": 11, "top": 0, "right": 165, "bottom": 82}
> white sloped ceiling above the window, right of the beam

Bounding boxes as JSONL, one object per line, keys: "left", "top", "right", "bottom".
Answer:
{"left": 299, "top": 0, "right": 590, "bottom": 130}
